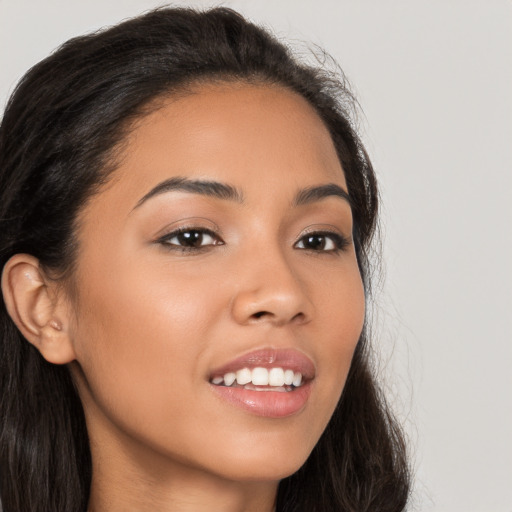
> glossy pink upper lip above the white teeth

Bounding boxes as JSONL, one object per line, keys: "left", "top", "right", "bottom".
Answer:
{"left": 210, "top": 348, "right": 315, "bottom": 380}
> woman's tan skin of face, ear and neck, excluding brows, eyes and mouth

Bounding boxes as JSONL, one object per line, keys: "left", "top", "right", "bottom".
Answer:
{"left": 4, "top": 83, "right": 364, "bottom": 512}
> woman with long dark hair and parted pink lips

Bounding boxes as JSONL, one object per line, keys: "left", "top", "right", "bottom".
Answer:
{"left": 0, "top": 5, "right": 408, "bottom": 512}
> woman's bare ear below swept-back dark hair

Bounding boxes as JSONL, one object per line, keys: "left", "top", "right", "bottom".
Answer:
{"left": 2, "top": 254, "right": 76, "bottom": 364}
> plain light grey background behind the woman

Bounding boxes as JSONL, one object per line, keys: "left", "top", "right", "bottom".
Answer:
{"left": 0, "top": 0, "right": 512, "bottom": 512}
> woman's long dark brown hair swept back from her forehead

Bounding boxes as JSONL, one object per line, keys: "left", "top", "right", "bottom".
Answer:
{"left": 0, "top": 8, "right": 409, "bottom": 512}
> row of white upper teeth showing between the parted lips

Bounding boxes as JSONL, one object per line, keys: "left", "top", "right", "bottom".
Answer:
{"left": 211, "top": 367, "right": 302, "bottom": 391}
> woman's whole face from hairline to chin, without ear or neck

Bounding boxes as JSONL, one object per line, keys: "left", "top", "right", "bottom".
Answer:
{"left": 70, "top": 84, "right": 364, "bottom": 480}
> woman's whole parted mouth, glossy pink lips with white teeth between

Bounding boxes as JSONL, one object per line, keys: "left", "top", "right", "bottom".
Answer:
{"left": 209, "top": 349, "right": 315, "bottom": 418}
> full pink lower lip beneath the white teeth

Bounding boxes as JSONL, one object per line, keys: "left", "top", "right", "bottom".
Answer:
{"left": 211, "top": 381, "right": 311, "bottom": 418}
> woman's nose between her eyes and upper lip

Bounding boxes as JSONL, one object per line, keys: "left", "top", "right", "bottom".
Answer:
{"left": 232, "top": 251, "right": 314, "bottom": 326}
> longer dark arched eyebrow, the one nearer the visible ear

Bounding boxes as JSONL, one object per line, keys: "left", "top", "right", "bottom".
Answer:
{"left": 134, "top": 177, "right": 244, "bottom": 209}
